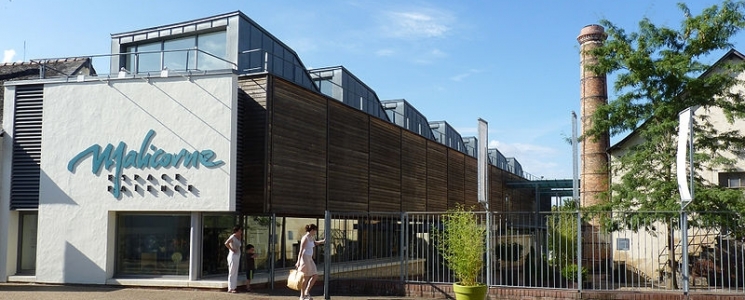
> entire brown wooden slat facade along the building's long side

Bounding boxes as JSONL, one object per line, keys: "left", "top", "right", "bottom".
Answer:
{"left": 238, "top": 75, "right": 534, "bottom": 217}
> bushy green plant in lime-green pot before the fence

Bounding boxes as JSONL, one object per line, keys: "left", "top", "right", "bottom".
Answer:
{"left": 438, "top": 204, "right": 488, "bottom": 300}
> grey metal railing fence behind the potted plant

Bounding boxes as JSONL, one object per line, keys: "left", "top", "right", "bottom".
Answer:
{"left": 326, "top": 211, "right": 745, "bottom": 293}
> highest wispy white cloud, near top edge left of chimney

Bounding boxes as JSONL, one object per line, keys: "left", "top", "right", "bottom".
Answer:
{"left": 381, "top": 9, "right": 453, "bottom": 39}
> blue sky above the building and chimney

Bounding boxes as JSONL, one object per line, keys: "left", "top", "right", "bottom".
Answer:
{"left": 0, "top": 0, "right": 744, "bottom": 179}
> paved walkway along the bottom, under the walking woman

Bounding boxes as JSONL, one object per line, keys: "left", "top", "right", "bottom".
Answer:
{"left": 0, "top": 283, "right": 412, "bottom": 300}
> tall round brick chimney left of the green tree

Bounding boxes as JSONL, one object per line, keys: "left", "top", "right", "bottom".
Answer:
{"left": 577, "top": 25, "right": 610, "bottom": 206}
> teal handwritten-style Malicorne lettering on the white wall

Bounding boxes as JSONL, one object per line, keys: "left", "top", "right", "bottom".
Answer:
{"left": 67, "top": 129, "right": 224, "bottom": 198}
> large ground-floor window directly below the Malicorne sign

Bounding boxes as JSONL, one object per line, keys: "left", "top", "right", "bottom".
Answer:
{"left": 116, "top": 214, "right": 191, "bottom": 276}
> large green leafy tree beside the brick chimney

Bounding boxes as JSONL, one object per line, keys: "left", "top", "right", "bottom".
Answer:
{"left": 583, "top": 1, "right": 745, "bottom": 287}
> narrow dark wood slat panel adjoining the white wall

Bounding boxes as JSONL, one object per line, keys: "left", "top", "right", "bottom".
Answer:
{"left": 236, "top": 77, "right": 268, "bottom": 214}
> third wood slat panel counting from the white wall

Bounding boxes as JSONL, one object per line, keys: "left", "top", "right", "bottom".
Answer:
{"left": 328, "top": 100, "right": 370, "bottom": 212}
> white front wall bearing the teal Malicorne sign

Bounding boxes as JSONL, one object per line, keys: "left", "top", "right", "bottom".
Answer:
{"left": 36, "top": 74, "right": 237, "bottom": 284}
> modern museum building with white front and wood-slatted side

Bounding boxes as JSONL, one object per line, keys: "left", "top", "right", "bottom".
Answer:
{"left": 0, "top": 12, "right": 548, "bottom": 286}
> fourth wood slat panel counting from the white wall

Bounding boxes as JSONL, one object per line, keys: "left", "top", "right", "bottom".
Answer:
{"left": 370, "top": 117, "right": 401, "bottom": 211}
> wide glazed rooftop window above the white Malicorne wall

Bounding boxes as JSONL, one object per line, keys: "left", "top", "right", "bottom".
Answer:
{"left": 124, "top": 31, "right": 230, "bottom": 73}
